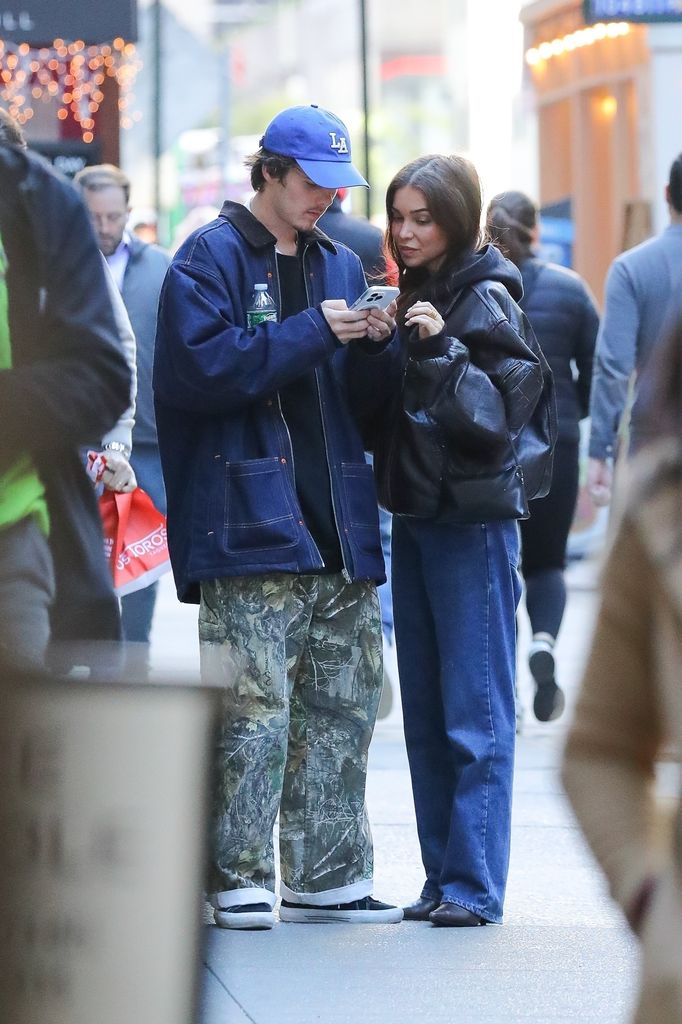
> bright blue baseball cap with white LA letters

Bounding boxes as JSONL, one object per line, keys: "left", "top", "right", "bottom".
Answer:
{"left": 260, "top": 103, "right": 370, "bottom": 188}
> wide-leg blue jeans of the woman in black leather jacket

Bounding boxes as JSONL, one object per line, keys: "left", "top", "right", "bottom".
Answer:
{"left": 391, "top": 516, "right": 521, "bottom": 922}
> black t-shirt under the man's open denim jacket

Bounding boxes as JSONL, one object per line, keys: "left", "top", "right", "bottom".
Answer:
{"left": 278, "top": 253, "right": 343, "bottom": 573}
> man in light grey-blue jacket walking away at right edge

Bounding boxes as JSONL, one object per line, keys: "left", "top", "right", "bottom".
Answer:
{"left": 588, "top": 153, "right": 682, "bottom": 505}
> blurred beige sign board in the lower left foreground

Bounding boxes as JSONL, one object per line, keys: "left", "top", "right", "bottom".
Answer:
{"left": 0, "top": 678, "right": 213, "bottom": 1024}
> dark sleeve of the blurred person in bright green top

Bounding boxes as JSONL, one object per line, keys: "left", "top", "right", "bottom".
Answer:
{"left": 0, "top": 168, "right": 130, "bottom": 461}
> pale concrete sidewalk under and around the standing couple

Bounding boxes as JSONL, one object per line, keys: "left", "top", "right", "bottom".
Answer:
{"left": 148, "top": 563, "right": 636, "bottom": 1024}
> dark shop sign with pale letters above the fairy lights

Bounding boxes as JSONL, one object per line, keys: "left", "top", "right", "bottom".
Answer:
{"left": 0, "top": 0, "right": 137, "bottom": 46}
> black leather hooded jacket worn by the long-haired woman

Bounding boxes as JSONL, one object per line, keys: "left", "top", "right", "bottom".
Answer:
{"left": 374, "top": 246, "right": 556, "bottom": 523}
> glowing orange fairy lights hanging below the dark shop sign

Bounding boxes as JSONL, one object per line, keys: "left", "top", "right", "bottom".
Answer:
{"left": 0, "top": 38, "right": 141, "bottom": 142}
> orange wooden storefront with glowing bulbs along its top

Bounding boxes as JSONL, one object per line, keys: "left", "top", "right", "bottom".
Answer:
{"left": 521, "top": 0, "right": 682, "bottom": 298}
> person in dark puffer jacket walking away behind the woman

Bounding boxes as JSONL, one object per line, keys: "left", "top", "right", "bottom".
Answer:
{"left": 487, "top": 191, "right": 599, "bottom": 722}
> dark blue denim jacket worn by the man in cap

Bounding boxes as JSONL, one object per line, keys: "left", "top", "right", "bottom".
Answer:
{"left": 154, "top": 197, "right": 399, "bottom": 602}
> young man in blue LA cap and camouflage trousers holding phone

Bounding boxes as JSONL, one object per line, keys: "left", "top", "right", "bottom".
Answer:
{"left": 155, "top": 105, "right": 402, "bottom": 929}
